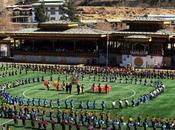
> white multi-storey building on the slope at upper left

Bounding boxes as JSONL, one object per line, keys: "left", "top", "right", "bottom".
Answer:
{"left": 5, "top": 0, "right": 65, "bottom": 23}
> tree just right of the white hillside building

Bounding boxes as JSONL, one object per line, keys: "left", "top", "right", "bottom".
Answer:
{"left": 60, "top": 0, "right": 79, "bottom": 22}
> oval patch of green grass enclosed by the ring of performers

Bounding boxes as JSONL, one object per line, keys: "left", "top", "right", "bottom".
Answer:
{"left": 8, "top": 75, "right": 153, "bottom": 103}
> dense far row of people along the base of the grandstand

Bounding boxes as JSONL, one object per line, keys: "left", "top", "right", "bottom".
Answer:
{"left": 0, "top": 63, "right": 175, "bottom": 79}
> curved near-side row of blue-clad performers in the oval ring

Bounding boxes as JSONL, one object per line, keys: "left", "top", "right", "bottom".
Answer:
{"left": 1, "top": 82, "right": 165, "bottom": 110}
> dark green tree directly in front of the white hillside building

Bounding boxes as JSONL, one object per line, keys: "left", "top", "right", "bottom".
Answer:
{"left": 35, "top": 3, "right": 48, "bottom": 23}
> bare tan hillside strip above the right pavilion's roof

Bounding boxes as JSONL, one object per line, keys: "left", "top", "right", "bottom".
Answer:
{"left": 78, "top": 6, "right": 175, "bottom": 20}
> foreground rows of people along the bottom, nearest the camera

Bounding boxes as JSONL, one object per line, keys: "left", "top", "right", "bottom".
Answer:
{"left": 0, "top": 106, "right": 175, "bottom": 130}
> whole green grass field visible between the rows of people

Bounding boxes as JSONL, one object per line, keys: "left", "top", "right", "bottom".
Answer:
{"left": 0, "top": 66, "right": 175, "bottom": 130}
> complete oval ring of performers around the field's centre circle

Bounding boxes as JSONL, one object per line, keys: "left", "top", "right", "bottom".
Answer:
{"left": 0, "top": 64, "right": 165, "bottom": 110}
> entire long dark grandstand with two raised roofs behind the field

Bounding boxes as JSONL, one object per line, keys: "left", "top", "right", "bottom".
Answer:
{"left": 0, "top": 18, "right": 175, "bottom": 68}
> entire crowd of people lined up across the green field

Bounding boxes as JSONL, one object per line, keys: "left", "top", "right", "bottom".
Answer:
{"left": 0, "top": 63, "right": 172, "bottom": 130}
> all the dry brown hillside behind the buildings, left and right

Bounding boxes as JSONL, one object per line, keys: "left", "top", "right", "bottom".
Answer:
{"left": 0, "top": 0, "right": 175, "bottom": 30}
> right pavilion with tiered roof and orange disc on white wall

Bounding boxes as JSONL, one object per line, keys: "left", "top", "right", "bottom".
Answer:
{"left": 111, "top": 17, "right": 174, "bottom": 67}
